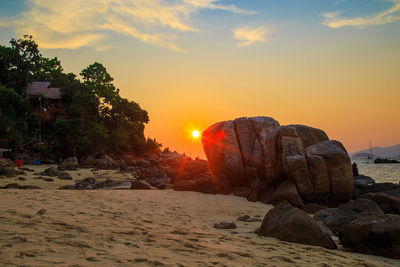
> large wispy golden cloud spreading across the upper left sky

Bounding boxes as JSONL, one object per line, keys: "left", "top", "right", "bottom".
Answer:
{"left": 0, "top": 0, "right": 254, "bottom": 51}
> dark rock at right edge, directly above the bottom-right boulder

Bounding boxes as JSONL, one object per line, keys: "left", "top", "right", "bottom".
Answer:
{"left": 361, "top": 188, "right": 400, "bottom": 215}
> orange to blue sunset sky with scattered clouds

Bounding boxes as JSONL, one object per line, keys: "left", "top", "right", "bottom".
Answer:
{"left": 0, "top": 0, "right": 400, "bottom": 158}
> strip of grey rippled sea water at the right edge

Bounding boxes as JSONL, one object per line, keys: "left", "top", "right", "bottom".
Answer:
{"left": 351, "top": 158, "right": 400, "bottom": 184}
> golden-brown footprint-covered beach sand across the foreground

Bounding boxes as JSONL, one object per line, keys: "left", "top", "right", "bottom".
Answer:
{"left": 0, "top": 165, "right": 400, "bottom": 266}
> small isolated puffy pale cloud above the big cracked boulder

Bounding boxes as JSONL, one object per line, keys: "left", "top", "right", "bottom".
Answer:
{"left": 233, "top": 27, "right": 270, "bottom": 47}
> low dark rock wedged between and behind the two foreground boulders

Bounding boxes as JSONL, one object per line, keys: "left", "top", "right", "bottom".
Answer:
{"left": 314, "top": 199, "right": 383, "bottom": 234}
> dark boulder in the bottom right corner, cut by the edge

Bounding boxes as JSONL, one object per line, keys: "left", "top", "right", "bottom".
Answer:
{"left": 339, "top": 214, "right": 400, "bottom": 259}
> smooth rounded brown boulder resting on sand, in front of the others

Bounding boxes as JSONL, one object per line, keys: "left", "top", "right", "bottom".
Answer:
{"left": 258, "top": 202, "right": 337, "bottom": 249}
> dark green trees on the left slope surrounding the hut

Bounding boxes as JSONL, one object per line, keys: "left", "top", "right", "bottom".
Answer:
{"left": 0, "top": 35, "right": 160, "bottom": 157}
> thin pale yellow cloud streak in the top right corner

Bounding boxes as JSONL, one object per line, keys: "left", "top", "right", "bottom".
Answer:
{"left": 321, "top": 0, "right": 400, "bottom": 28}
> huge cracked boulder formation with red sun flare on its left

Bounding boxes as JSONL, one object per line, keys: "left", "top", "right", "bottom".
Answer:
{"left": 202, "top": 117, "right": 353, "bottom": 207}
